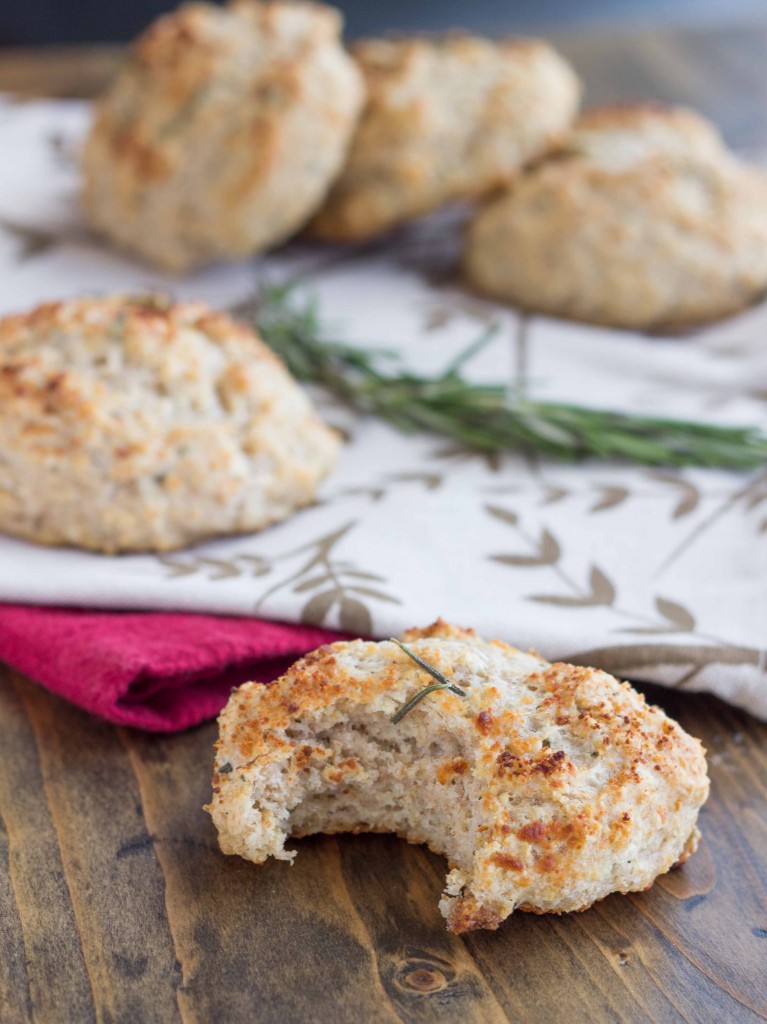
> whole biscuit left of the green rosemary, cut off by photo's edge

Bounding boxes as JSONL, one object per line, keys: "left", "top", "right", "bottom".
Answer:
{"left": 0, "top": 296, "right": 339, "bottom": 553}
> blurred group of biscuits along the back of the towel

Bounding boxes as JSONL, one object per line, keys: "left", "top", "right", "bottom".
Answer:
{"left": 79, "top": 0, "right": 767, "bottom": 330}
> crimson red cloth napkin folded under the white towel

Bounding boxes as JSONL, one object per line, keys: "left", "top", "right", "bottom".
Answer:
{"left": 0, "top": 604, "right": 346, "bottom": 732}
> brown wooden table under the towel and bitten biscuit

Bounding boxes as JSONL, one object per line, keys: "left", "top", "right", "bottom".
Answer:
{"left": 0, "top": 23, "right": 767, "bottom": 1024}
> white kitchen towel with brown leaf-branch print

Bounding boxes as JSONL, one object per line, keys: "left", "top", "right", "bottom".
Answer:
{"left": 0, "top": 100, "right": 767, "bottom": 718}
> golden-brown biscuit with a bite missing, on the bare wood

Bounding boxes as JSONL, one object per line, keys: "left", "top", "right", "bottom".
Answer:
{"left": 208, "top": 621, "right": 709, "bottom": 932}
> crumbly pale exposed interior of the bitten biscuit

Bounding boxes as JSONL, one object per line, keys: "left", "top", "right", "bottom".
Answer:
{"left": 245, "top": 697, "right": 482, "bottom": 870}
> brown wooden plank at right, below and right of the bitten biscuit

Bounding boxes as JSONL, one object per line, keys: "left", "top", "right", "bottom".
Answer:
{"left": 458, "top": 687, "right": 767, "bottom": 1022}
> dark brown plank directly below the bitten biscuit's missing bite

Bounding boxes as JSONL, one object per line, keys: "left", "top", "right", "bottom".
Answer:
{"left": 121, "top": 725, "right": 409, "bottom": 1024}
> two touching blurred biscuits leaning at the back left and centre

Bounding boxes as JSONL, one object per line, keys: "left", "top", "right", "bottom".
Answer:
{"left": 84, "top": 0, "right": 580, "bottom": 271}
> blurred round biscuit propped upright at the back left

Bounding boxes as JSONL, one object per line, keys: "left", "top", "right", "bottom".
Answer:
{"left": 84, "top": 0, "right": 363, "bottom": 270}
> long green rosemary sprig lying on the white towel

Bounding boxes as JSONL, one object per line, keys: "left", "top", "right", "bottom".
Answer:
{"left": 252, "top": 286, "right": 767, "bottom": 469}
